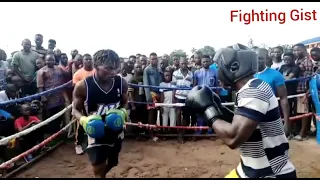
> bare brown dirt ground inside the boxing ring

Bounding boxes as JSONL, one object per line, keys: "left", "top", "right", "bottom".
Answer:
{"left": 17, "top": 139, "right": 320, "bottom": 178}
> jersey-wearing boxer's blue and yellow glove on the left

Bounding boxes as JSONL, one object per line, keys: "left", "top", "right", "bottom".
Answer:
{"left": 80, "top": 115, "right": 105, "bottom": 138}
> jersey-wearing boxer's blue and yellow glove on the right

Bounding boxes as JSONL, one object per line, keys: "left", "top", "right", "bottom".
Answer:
{"left": 105, "top": 108, "right": 128, "bottom": 131}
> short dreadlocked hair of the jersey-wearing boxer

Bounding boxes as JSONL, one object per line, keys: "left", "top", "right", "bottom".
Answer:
{"left": 93, "top": 49, "right": 120, "bottom": 68}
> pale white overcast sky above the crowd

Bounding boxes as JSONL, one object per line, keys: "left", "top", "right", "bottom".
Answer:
{"left": 0, "top": 2, "right": 320, "bottom": 57}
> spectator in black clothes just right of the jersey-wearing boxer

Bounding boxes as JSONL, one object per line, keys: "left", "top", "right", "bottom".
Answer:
{"left": 128, "top": 62, "right": 148, "bottom": 140}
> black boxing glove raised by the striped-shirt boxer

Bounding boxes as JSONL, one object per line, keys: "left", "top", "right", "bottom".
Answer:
{"left": 185, "top": 86, "right": 222, "bottom": 127}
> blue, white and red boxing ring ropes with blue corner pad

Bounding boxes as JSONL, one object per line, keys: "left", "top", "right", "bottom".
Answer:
{"left": 0, "top": 76, "right": 320, "bottom": 177}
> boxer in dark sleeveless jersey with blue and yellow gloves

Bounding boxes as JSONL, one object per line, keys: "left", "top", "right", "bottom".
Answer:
{"left": 72, "top": 50, "right": 128, "bottom": 178}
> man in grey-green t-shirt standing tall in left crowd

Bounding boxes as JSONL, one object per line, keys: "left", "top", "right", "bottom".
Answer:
{"left": 12, "top": 39, "right": 39, "bottom": 95}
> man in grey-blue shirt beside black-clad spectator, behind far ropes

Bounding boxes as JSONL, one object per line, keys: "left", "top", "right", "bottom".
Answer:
{"left": 143, "top": 53, "right": 162, "bottom": 141}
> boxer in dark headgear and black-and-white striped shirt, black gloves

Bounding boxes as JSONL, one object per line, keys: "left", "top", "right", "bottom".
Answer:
{"left": 186, "top": 45, "right": 297, "bottom": 178}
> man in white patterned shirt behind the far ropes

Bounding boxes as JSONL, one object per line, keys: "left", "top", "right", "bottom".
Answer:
{"left": 172, "top": 57, "right": 194, "bottom": 143}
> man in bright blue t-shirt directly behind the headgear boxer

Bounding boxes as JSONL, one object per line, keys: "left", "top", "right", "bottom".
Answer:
{"left": 254, "top": 48, "right": 291, "bottom": 137}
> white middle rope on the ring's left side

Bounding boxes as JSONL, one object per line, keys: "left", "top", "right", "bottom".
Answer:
{"left": 0, "top": 104, "right": 72, "bottom": 146}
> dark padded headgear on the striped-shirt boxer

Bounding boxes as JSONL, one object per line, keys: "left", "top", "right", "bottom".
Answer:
{"left": 214, "top": 44, "right": 258, "bottom": 86}
